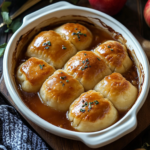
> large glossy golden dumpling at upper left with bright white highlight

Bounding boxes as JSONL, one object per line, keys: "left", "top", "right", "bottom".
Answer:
{"left": 26, "top": 30, "right": 76, "bottom": 69}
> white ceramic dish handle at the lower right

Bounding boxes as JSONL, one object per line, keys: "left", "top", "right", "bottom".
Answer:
{"left": 80, "top": 114, "right": 137, "bottom": 148}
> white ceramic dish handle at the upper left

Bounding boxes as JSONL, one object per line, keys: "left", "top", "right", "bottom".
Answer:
{"left": 23, "top": 1, "right": 74, "bottom": 24}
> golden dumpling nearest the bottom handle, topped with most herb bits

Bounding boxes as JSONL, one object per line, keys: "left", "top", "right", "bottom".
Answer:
{"left": 68, "top": 90, "right": 118, "bottom": 132}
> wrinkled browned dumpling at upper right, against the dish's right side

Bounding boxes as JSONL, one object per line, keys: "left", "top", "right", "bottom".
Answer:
{"left": 94, "top": 40, "right": 132, "bottom": 73}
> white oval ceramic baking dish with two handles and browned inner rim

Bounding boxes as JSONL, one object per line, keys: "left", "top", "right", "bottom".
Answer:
{"left": 3, "top": 2, "right": 150, "bottom": 148}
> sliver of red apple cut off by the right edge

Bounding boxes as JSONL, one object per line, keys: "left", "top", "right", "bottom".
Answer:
{"left": 144, "top": 0, "right": 150, "bottom": 27}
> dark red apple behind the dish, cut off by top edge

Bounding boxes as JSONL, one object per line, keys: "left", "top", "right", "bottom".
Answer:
{"left": 89, "top": 0, "right": 127, "bottom": 16}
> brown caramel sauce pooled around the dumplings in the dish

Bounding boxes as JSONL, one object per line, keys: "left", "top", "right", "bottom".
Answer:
{"left": 15, "top": 22, "right": 139, "bottom": 131}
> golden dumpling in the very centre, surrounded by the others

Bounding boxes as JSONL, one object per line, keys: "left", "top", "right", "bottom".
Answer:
{"left": 64, "top": 51, "right": 112, "bottom": 90}
